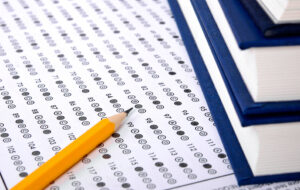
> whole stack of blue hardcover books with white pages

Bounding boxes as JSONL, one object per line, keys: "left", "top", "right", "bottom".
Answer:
{"left": 169, "top": 0, "right": 300, "bottom": 185}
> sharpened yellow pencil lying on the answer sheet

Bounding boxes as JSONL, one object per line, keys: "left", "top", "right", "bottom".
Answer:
{"left": 11, "top": 108, "right": 132, "bottom": 190}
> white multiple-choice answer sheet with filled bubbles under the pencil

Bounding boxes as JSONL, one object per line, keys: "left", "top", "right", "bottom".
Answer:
{"left": 0, "top": 0, "right": 300, "bottom": 190}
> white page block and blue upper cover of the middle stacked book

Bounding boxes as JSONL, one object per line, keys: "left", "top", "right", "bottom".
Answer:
{"left": 217, "top": 0, "right": 300, "bottom": 102}
